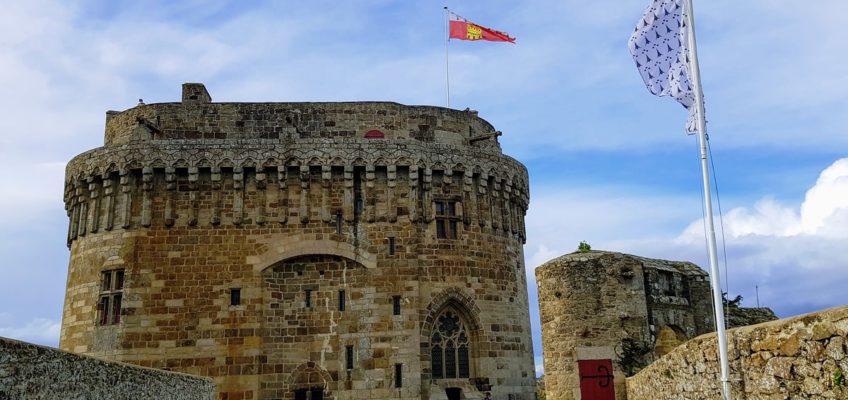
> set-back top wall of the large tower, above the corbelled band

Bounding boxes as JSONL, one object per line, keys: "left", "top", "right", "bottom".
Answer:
{"left": 105, "top": 83, "right": 500, "bottom": 150}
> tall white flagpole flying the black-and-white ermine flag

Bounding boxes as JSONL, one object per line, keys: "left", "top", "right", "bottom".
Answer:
{"left": 686, "top": 0, "right": 731, "bottom": 400}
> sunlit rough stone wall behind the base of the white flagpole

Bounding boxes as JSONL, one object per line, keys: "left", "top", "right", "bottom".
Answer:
{"left": 627, "top": 306, "right": 848, "bottom": 400}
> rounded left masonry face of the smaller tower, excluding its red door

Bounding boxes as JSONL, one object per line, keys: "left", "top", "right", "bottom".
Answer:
{"left": 536, "top": 252, "right": 649, "bottom": 400}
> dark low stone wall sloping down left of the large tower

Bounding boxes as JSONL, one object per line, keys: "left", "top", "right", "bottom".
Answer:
{"left": 0, "top": 337, "right": 215, "bottom": 400}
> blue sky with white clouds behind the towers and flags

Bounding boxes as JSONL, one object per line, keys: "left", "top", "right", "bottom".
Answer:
{"left": 0, "top": 0, "right": 848, "bottom": 376}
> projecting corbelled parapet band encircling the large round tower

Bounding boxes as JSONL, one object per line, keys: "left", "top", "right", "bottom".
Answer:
{"left": 65, "top": 139, "right": 529, "bottom": 243}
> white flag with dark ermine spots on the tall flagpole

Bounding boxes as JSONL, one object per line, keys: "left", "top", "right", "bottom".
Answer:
{"left": 628, "top": 0, "right": 697, "bottom": 133}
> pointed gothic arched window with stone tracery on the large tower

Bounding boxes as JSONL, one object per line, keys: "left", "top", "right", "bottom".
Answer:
{"left": 430, "top": 310, "right": 471, "bottom": 379}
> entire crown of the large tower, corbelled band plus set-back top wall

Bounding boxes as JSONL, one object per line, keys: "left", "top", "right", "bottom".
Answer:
{"left": 65, "top": 84, "right": 529, "bottom": 244}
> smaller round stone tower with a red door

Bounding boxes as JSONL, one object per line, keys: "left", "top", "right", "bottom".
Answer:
{"left": 536, "top": 251, "right": 713, "bottom": 400}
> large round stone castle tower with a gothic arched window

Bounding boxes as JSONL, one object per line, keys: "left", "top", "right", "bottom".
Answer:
{"left": 60, "top": 84, "right": 535, "bottom": 400}
